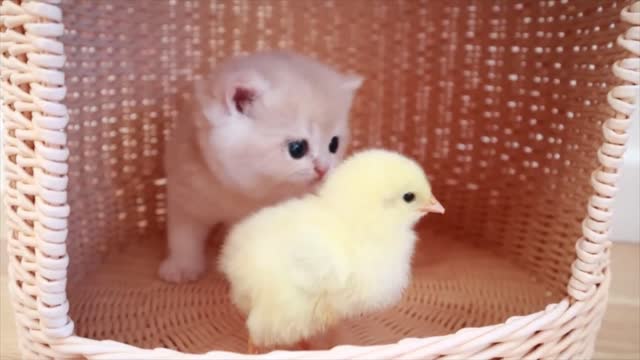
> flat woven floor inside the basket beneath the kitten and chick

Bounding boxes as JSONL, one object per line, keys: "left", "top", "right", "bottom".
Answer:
{"left": 68, "top": 231, "right": 561, "bottom": 353}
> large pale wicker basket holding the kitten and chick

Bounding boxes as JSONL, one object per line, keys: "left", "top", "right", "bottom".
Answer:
{"left": 0, "top": 0, "right": 640, "bottom": 359}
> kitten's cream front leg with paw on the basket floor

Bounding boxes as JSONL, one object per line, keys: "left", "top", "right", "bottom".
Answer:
{"left": 158, "top": 209, "right": 209, "bottom": 283}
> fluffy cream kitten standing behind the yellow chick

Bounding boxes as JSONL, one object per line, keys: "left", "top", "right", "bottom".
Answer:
{"left": 159, "top": 51, "right": 362, "bottom": 282}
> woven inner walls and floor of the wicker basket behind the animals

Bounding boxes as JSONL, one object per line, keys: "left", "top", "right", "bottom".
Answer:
{"left": 63, "top": 0, "right": 623, "bottom": 352}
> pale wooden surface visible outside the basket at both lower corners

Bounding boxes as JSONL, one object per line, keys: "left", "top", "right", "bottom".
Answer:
{"left": 0, "top": 218, "right": 640, "bottom": 360}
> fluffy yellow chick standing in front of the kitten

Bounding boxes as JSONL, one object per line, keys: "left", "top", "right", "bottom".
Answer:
{"left": 219, "top": 149, "right": 444, "bottom": 353}
